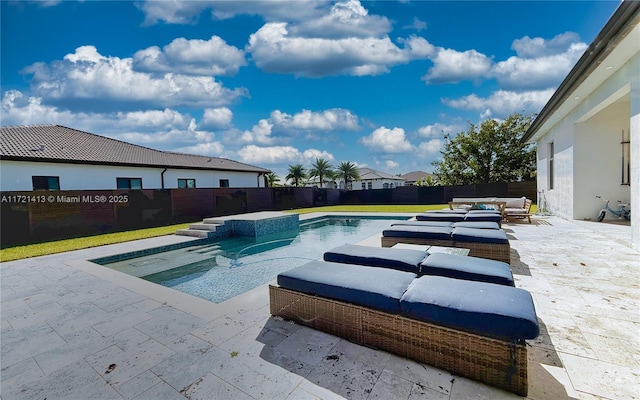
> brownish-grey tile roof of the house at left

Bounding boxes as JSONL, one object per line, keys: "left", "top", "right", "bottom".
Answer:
{"left": 0, "top": 125, "right": 270, "bottom": 173}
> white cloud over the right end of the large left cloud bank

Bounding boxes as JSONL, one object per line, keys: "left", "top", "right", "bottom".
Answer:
{"left": 133, "top": 36, "right": 247, "bottom": 76}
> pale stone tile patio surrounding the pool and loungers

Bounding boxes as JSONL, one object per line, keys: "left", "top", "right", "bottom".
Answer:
{"left": 0, "top": 217, "right": 640, "bottom": 400}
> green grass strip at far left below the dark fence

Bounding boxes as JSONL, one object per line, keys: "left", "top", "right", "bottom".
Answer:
{"left": 0, "top": 224, "right": 189, "bottom": 262}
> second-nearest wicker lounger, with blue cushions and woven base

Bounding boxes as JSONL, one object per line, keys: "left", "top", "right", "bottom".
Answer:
{"left": 381, "top": 225, "right": 511, "bottom": 264}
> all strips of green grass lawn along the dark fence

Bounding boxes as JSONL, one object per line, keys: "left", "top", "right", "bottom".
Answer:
{"left": 0, "top": 204, "right": 537, "bottom": 262}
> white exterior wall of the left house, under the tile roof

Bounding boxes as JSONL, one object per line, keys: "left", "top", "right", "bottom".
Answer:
{"left": 0, "top": 160, "right": 264, "bottom": 191}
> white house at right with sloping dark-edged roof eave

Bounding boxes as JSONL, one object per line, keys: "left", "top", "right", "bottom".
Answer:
{"left": 524, "top": 1, "right": 640, "bottom": 250}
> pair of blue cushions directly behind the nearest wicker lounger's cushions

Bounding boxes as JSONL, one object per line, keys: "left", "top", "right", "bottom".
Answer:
{"left": 323, "top": 244, "right": 515, "bottom": 286}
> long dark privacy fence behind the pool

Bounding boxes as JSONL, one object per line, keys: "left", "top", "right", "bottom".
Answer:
{"left": 0, "top": 182, "right": 536, "bottom": 247}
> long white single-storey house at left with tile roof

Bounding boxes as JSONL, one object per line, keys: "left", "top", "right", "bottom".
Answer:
{"left": 0, "top": 125, "right": 270, "bottom": 191}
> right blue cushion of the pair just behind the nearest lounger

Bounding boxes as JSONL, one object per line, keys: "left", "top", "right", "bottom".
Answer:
{"left": 420, "top": 253, "right": 515, "bottom": 286}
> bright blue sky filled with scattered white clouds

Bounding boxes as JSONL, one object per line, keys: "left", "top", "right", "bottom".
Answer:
{"left": 0, "top": 0, "right": 619, "bottom": 177}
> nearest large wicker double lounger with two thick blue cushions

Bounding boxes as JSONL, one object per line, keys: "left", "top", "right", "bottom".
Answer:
{"left": 269, "top": 261, "right": 539, "bottom": 396}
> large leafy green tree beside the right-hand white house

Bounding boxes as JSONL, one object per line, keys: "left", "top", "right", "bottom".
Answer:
{"left": 432, "top": 113, "right": 536, "bottom": 185}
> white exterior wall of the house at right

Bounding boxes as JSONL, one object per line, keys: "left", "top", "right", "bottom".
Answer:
{"left": 536, "top": 53, "right": 640, "bottom": 249}
